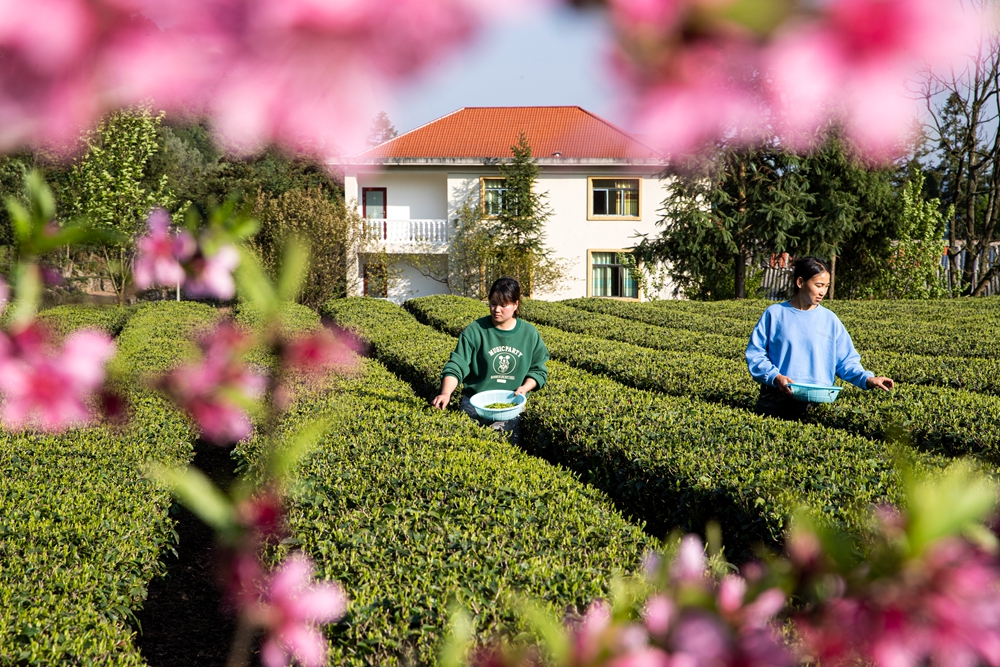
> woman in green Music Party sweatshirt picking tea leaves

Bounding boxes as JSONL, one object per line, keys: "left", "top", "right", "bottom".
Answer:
{"left": 432, "top": 278, "right": 549, "bottom": 442}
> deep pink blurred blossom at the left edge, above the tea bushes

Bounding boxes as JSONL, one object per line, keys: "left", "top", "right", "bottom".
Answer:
{"left": 0, "top": 323, "right": 115, "bottom": 432}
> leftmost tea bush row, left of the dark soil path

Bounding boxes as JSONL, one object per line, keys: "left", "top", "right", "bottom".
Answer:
{"left": 0, "top": 302, "right": 215, "bottom": 665}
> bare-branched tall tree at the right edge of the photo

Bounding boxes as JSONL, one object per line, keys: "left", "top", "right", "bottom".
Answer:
{"left": 922, "top": 0, "right": 1000, "bottom": 296}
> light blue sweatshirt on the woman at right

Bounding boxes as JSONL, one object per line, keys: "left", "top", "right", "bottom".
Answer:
{"left": 746, "top": 301, "right": 874, "bottom": 389}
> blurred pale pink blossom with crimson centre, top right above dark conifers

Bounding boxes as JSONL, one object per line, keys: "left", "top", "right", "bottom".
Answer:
{"left": 763, "top": 0, "right": 980, "bottom": 157}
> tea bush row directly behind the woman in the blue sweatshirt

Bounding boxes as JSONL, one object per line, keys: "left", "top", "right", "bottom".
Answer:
{"left": 407, "top": 296, "right": 1000, "bottom": 464}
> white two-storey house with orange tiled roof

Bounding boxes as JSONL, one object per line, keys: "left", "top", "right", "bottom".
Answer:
{"left": 341, "top": 107, "right": 669, "bottom": 301}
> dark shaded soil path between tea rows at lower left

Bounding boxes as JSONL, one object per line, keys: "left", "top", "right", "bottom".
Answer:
{"left": 136, "top": 442, "right": 258, "bottom": 667}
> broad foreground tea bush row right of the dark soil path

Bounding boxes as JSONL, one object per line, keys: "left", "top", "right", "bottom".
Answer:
{"left": 240, "top": 352, "right": 656, "bottom": 665}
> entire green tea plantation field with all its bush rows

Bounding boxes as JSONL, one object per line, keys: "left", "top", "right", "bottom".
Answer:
{"left": 0, "top": 296, "right": 1000, "bottom": 665}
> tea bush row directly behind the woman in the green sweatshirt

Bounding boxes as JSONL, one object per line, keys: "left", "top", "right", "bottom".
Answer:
{"left": 326, "top": 299, "right": 943, "bottom": 548}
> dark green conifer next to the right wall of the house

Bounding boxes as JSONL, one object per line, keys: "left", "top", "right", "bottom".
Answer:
{"left": 635, "top": 143, "right": 813, "bottom": 299}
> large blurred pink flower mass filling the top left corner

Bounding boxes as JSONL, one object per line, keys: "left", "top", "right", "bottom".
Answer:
{"left": 0, "top": 0, "right": 518, "bottom": 155}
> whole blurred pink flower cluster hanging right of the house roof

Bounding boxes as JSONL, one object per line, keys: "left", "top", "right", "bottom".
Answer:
{"left": 610, "top": 0, "right": 985, "bottom": 157}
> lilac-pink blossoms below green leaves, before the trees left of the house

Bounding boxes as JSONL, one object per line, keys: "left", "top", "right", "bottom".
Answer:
{"left": 132, "top": 209, "right": 240, "bottom": 300}
